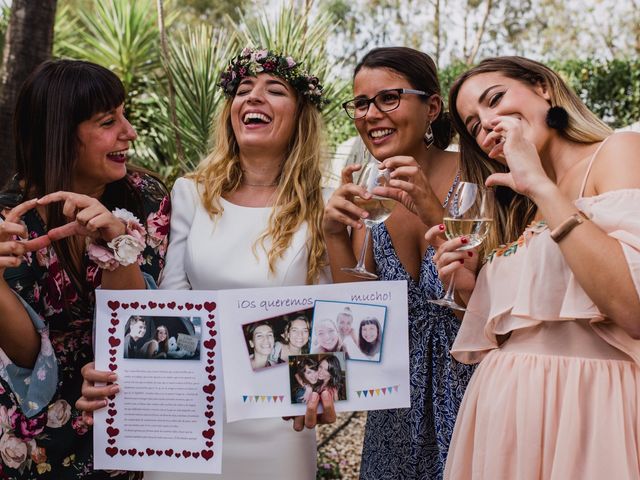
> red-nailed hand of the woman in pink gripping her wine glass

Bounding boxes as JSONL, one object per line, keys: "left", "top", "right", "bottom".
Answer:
{"left": 425, "top": 224, "right": 479, "bottom": 299}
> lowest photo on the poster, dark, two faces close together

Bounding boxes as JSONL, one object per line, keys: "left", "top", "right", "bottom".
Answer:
{"left": 289, "top": 352, "right": 347, "bottom": 403}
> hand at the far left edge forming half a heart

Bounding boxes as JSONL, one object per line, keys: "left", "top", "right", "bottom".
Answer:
{"left": 0, "top": 199, "right": 51, "bottom": 278}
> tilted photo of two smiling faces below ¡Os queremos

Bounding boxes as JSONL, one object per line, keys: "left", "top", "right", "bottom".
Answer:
{"left": 242, "top": 308, "right": 313, "bottom": 371}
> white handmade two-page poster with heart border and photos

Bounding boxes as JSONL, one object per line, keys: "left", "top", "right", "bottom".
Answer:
{"left": 93, "top": 282, "right": 409, "bottom": 473}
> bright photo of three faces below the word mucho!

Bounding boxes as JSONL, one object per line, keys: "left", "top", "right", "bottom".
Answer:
{"left": 311, "top": 300, "right": 387, "bottom": 362}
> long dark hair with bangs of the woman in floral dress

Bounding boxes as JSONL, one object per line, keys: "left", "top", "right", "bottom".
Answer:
{"left": 10, "top": 60, "right": 156, "bottom": 297}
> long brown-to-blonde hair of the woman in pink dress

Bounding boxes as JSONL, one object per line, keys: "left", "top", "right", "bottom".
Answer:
{"left": 449, "top": 56, "right": 613, "bottom": 253}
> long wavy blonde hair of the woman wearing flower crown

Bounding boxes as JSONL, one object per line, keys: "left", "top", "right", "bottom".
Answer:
{"left": 187, "top": 96, "right": 326, "bottom": 284}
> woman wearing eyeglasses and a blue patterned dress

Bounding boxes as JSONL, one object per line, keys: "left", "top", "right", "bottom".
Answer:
{"left": 323, "top": 47, "right": 472, "bottom": 479}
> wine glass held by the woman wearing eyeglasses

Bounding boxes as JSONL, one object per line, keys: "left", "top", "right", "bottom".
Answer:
{"left": 342, "top": 147, "right": 396, "bottom": 280}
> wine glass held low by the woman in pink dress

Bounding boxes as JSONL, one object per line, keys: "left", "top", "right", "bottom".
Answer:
{"left": 429, "top": 182, "right": 495, "bottom": 311}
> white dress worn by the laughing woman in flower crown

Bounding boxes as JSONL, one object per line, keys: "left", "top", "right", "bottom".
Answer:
{"left": 145, "top": 178, "right": 327, "bottom": 480}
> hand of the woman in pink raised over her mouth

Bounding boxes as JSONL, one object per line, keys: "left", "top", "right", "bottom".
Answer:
{"left": 480, "top": 116, "right": 553, "bottom": 198}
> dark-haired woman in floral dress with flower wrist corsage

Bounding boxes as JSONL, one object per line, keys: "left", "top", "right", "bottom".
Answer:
{"left": 0, "top": 60, "right": 170, "bottom": 480}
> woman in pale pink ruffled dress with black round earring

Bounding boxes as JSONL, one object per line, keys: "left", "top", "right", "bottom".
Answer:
{"left": 427, "top": 57, "right": 640, "bottom": 480}
